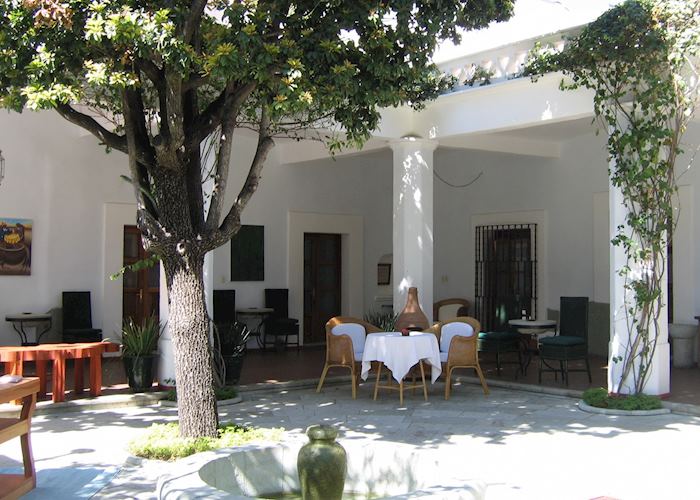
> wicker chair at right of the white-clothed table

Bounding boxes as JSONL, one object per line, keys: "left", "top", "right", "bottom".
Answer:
{"left": 428, "top": 316, "right": 489, "bottom": 399}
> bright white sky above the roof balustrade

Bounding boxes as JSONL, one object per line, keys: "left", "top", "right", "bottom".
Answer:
{"left": 433, "top": 0, "right": 622, "bottom": 64}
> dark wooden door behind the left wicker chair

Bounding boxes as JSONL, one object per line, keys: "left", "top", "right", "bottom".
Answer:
{"left": 304, "top": 233, "right": 341, "bottom": 344}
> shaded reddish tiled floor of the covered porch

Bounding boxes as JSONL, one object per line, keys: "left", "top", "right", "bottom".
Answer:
{"left": 17, "top": 346, "right": 700, "bottom": 405}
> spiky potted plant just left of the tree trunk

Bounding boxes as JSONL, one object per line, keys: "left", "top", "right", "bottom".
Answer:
{"left": 122, "top": 315, "right": 163, "bottom": 392}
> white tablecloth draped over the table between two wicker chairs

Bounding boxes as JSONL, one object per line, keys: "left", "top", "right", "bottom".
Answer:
{"left": 361, "top": 332, "right": 442, "bottom": 383}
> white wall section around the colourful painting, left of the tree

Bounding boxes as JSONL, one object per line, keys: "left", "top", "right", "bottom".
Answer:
{"left": 0, "top": 112, "right": 133, "bottom": 344}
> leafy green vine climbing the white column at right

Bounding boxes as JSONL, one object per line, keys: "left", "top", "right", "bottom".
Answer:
{"left": 525, "top": 0, "right": 700, "bottom": 394}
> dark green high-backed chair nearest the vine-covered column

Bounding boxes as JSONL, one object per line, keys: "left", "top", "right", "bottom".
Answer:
{"left": 539, "top": 297, "right": 592, "bottom": 385}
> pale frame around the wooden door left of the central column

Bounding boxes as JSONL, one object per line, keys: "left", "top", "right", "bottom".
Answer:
{"left": 287, "top": 212, "right": 365, "bottom": 345}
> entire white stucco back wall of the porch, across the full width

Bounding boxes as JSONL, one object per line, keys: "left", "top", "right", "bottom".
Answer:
{"left": 0, "top": 113, "right": 700, "bottom": 354}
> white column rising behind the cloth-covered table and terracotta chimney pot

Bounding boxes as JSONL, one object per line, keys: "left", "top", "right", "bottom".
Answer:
{"left": 390, "top": 137, "right": 438, "bottom": 321}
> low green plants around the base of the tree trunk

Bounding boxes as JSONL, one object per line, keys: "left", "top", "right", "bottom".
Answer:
{"left": 129, "top": 422, "right": 284, "bottom": 460}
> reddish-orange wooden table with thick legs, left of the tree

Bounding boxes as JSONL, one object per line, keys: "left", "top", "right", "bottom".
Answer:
{"left": 0, "top": 342, "right": 119, "bottom": 403}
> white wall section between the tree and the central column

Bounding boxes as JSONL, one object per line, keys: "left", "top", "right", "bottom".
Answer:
{"left": 214, "top": 148, "right": 392, "bottom": 318}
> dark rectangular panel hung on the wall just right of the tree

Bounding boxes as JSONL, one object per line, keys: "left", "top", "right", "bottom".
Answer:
{"left": 231, "top": 225, "right": 265, "bottom": 281}
